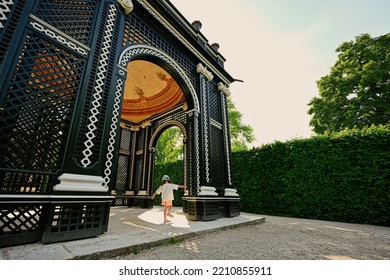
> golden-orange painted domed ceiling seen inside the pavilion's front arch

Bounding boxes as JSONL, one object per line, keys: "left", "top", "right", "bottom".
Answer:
{"left": 121, "top": 60, "right": 185, "bottom": 123}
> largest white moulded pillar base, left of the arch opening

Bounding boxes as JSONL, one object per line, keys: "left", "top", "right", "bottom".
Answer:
{"left": 54, "top": 173, "right": 108, "bottom": 192}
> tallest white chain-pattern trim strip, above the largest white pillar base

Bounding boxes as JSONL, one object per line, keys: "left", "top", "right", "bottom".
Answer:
{"left": 81, "top": 4, "right": 117, "bottom": 168}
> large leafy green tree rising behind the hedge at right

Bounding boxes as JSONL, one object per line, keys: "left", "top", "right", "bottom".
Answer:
{"left": 308, "top": 33, "right": 390, "bottom": 134}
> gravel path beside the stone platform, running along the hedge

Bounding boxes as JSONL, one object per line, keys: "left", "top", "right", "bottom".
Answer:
{"left": 110, "top": 216, "right": 390, "bottom": 260}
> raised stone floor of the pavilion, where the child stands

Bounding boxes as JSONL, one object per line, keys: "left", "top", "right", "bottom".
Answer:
{"left": 0, "top": 206, "right": 265, "bottom": 260}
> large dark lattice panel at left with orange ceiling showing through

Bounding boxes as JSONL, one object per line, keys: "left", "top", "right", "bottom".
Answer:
{"left": 0, "top": 34, "right": 84, "bottom": 175}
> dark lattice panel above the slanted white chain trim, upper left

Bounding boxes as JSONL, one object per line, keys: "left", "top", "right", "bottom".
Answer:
{"left": 34, "top": 0, "right": 99, "bottom": 45}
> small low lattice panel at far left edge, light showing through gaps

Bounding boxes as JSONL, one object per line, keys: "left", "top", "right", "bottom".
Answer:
{"left": 0, "top": 205, "right": 42, "bottom": 236}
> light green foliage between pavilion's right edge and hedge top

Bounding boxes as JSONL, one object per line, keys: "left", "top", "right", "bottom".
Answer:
{"left": 227, "top": 98, "right": 256, "bottom": 152}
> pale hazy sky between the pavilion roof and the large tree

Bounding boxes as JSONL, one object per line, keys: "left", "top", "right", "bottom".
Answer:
{"left": 171, "top": 0, "right": 390, "bottom": 147}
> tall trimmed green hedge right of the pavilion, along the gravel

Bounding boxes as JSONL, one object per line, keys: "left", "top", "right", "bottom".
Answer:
{"left": 232, "top": 126, "right": 390, "bottom": 226}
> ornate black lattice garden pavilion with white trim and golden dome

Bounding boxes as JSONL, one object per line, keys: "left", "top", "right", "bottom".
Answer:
{"left": 0, "top": 0, "right": 240, "bottom": 247}
